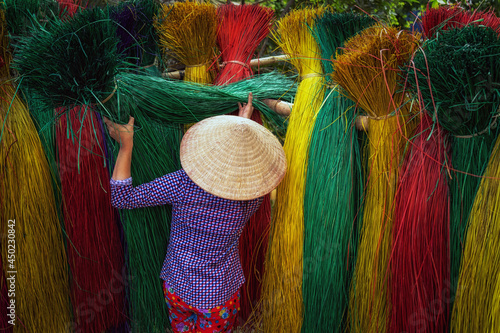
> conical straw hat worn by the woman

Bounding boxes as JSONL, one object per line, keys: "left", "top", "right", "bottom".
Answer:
{"left": 180, "top": 116, "right": 286, "bottom": 200}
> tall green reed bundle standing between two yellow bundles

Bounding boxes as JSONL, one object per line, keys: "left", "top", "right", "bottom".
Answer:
{"left": 302, "top": 12, "right": 375, "bottom": 332}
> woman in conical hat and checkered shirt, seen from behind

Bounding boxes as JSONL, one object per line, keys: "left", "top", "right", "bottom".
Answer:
{"left": 105, "top": 93, "right": 286, "bottom": 332}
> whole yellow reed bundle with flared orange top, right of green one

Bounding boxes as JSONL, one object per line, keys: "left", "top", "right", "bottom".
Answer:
{"left": 332, "top": 26, "right": 419, "bottom": 333}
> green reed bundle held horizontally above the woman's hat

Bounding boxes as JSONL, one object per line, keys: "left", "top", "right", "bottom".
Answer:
{"left": 101, "top": 73, "right": 297, "bottom": 138}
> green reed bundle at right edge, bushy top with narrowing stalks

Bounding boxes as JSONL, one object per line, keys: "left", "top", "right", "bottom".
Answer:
{"left": 411, "top": 26, "right": 500, "bottom": 300}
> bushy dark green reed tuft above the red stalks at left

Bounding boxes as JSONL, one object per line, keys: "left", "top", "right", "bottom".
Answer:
{"left": 13, "top": 8, "right": 121, "bottom": 108}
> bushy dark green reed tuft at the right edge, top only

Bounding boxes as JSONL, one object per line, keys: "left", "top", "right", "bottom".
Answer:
{"left": 409, "top": 25, "right": 500, "bottom": 137}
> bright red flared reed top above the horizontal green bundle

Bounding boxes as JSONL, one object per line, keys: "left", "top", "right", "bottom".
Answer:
{"left": 214, "top": 3, "right": 274, "bottom": 85}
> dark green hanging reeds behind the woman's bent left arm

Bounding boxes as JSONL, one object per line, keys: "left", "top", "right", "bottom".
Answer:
{"left": 103, "top": 109, "right": 182, "bottom": 333}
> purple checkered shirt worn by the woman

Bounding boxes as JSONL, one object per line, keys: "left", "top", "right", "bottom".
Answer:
{"left": 111, "top": 169, "right": 262, "bottom": 309}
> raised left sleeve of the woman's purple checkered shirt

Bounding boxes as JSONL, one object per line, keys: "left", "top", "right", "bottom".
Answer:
{"left": 110, "top": 170, "right": 184, "bottom": 209}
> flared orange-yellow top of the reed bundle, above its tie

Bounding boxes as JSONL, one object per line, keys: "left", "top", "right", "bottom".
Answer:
{"left": 331, "top": 25, "right": 420, "bottom": 119}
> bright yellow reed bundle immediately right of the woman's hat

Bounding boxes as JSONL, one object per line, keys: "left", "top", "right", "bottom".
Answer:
{"left": 262, "top": 8, "right": 325, "bottom": 333}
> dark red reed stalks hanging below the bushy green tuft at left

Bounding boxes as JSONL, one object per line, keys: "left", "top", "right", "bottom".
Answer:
{"left": 56, "top": 106, "right": 128, "bottom": 332}
